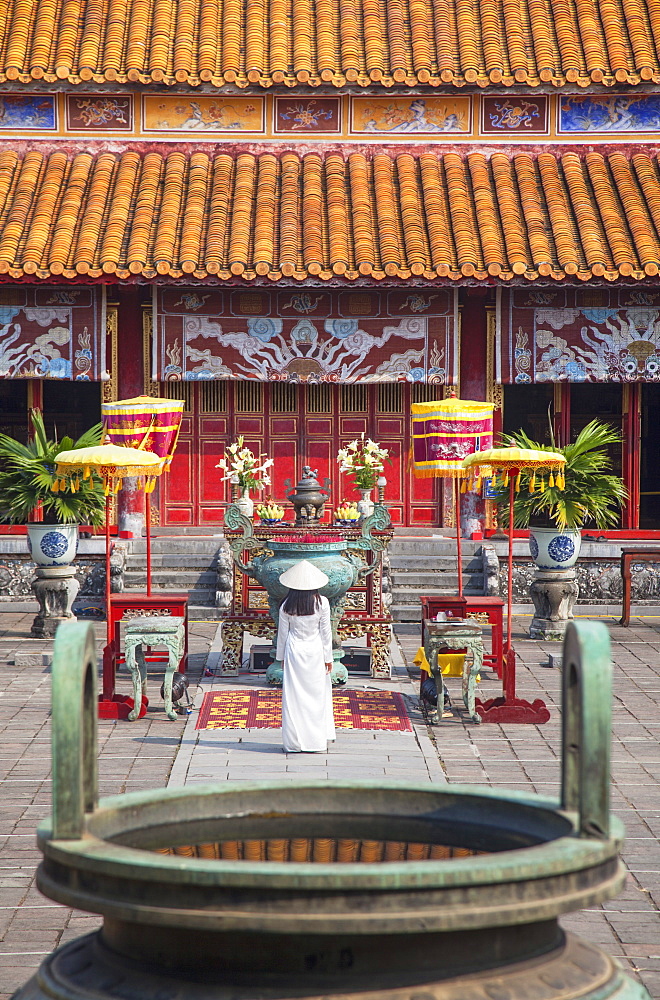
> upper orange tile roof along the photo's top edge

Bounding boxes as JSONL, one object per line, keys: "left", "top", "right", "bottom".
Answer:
{"left": 0, "top": 0, "right": 660, "bottom": 87}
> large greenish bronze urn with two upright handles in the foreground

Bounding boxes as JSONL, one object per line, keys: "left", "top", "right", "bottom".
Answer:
{"left": 14, "top": 623, "right": 649, "bottom": 1000}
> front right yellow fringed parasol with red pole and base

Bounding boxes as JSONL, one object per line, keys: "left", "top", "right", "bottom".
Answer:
{"left": 463, "top": 448, "right": 566, "bottom": 723}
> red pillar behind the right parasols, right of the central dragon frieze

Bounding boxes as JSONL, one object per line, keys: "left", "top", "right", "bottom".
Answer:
{"left": 460, "top": 288, "right": 490, "bottom": 536}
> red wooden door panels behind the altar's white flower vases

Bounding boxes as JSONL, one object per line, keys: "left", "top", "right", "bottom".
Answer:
{"left": 160, "top": 381, "right": 440, "bottom": 527}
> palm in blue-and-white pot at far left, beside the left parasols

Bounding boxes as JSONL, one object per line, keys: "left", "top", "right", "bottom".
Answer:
{"left": 0, "top": 409, "right": 105, "bottom": 566}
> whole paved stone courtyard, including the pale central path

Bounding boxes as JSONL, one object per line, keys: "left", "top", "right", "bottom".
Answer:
{"left": 0, "top": 612, "right": 660, "bottom": 1000}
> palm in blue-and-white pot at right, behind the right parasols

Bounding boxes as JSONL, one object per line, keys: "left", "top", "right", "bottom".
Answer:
{"left": 496, "top": 420, "right": 628, "bottom": 570}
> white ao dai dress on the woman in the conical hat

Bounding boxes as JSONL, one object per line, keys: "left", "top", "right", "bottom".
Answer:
{"left": 277, "top": 597, "right": 335, "bottom": 753}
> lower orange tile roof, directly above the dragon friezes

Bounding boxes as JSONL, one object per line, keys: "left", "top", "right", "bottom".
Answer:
{"left": 0, "top": 148, "right": 660, "bottom": 281}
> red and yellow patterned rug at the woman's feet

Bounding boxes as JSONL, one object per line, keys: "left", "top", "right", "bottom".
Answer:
{"left": 195, "top": 688, "right": 412, "bottom": 732}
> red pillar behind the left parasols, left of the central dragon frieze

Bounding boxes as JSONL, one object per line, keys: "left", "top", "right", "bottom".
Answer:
{"left": 117, "top": 285, "right": 144, "bottom": 537}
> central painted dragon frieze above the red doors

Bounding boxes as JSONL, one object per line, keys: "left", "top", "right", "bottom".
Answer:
{"left": 152, "top": 288, "right": 458, "bottom": 385}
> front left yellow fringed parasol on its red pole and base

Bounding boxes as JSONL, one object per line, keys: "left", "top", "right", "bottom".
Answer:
{"left": 53, "top": 444, "right": 163, "bottom": 718}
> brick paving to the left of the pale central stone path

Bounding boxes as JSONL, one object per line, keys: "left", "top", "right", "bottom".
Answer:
{"left": 0, "top": 612, "right": 216, "bottom": 1000}
